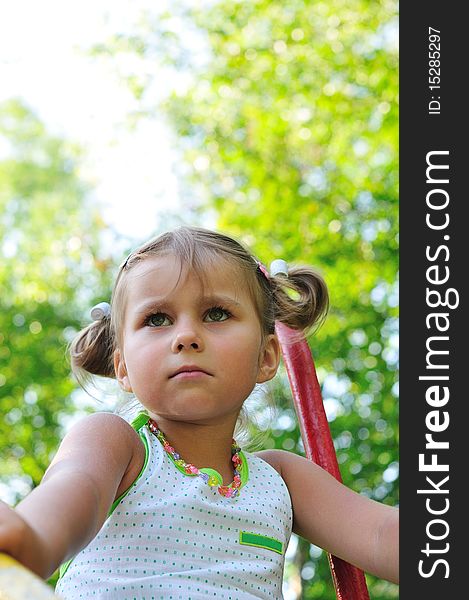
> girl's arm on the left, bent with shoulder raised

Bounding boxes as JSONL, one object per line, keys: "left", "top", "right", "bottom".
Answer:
{"left": 0, "top": 413, "right": 145, "bottom": 578}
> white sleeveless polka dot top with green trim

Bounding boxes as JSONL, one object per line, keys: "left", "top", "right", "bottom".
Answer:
{"left": 56, "top": 414, "right": 292, "bottom": 600}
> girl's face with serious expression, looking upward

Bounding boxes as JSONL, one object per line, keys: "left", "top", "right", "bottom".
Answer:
{"left": 115, "top": 255, "right": 279, "bottom": 424}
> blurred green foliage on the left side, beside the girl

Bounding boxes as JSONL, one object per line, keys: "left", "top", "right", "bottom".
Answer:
{"left": 0, "top": 100, "right": 111, "bottom": 501}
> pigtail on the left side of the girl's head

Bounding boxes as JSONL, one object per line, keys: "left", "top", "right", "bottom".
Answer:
{"left": 69, "top": 316, "right": 115, "bottom": 384}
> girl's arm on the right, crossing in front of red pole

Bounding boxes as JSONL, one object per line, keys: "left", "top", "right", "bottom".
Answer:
{"left": 258, "top": 450, "right": 399, "bottom": 583}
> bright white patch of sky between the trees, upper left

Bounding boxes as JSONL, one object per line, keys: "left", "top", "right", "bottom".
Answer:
{"left": 0, "top": 0, "right": 188, "bottom": 241}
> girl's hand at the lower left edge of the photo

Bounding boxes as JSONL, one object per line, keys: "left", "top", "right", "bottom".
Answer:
{"left": 0, "top": 500, "right": 47, "bottom": 572}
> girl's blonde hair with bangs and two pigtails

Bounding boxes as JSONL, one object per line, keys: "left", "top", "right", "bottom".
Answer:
{"left": 70, "top": 227, "right": 329, "bottom": 436}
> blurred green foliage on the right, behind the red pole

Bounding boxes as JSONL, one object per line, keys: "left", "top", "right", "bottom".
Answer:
{"left": 101, "top": 0, "right": 398, "bottom": 600}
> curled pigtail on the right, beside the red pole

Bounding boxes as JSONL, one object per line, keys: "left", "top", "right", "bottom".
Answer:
{"left": 270, "top": 265, "right": 329, "bottom": 331}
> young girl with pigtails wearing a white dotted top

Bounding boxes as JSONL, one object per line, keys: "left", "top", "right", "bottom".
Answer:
{"left": 0, "top": 227, "right": 398, "bottom": 600}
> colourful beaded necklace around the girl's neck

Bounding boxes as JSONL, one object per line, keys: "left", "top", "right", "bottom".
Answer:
{"left": 148, "top": 419, "right": 242, "bottom": 498}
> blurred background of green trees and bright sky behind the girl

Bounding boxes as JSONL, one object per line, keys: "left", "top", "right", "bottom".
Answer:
{"left": 0, "top": 0, "right": 399, "bottom": 600}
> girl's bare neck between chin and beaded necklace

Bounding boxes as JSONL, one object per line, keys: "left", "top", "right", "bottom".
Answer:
{"left": 150, "top": 413, "right": 236, "bottom": 485}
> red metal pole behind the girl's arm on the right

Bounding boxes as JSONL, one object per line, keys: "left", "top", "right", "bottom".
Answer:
{"left": 275, "top": 322, "right": 370, "bottom": 600}
